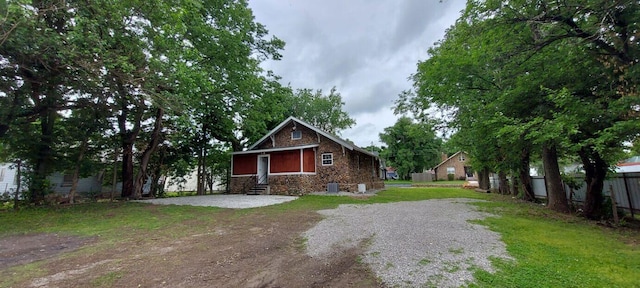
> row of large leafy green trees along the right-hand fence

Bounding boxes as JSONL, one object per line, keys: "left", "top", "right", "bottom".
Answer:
{"left": 395, "top": 0, "right": 640, "bottom": 219}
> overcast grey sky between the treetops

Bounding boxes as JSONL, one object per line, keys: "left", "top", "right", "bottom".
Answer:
{"left": 249, "top": 0, "right": 465, "bottom": 147}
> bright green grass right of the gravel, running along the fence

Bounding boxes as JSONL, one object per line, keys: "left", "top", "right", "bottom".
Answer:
{"left": 471, "top": 201, "right": 640, "bottom": 287}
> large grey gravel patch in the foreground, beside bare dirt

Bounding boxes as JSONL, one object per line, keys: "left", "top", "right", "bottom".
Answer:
{"left": 303, "top": 199, "right": 511, "bottom": 287}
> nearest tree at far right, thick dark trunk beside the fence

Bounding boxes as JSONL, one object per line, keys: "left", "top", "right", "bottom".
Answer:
{"left": 476, "top": 0, "right": 640, "bottom": 219}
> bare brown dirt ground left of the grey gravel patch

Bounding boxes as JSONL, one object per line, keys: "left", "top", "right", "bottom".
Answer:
{"left": 0, "top": 208, "right": 381, "bottom": 287}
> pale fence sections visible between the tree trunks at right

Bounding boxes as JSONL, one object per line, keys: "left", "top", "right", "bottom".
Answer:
{"left": 531, "top": 173, "right": 640, "bottom": 214}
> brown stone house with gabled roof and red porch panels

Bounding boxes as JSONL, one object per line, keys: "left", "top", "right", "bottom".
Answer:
{"left": 230, "top": 117, "right": 384, "bottom": 195}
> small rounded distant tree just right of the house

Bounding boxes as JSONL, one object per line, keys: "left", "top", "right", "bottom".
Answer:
{"left": 380, "top": 117, "right": 442, "bottom": 179}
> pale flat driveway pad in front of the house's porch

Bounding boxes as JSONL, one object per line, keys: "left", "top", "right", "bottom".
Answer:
{"left": 135, "top": 194, "right": 298, "bottom": 209}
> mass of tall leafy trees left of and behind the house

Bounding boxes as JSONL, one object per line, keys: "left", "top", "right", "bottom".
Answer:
{"left": 0, "top": 0, "right": 355, "bottom": 204}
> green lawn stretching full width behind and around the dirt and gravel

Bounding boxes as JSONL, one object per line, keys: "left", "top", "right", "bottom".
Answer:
{"left": 0, "top": 188, "right": 640, "bottom": 287}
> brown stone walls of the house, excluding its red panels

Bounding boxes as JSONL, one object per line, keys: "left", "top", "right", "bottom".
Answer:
{"left": 230, "top": 119, "right": 384, "bottom": 195}
